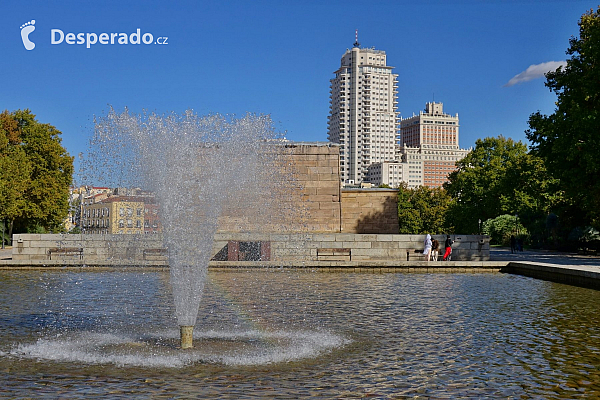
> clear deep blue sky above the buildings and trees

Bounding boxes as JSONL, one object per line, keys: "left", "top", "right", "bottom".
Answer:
{"left": 0, "top": 0, "right": 597, "bottom": 172}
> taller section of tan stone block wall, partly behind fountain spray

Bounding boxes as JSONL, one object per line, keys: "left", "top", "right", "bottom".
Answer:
{"left": 213, "top": 143, "right": 341, "bottom": 233}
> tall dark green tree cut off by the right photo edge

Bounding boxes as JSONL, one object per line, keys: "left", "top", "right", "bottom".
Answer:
{"left": 526, "top": 8, "right": 600, "bottom": 228}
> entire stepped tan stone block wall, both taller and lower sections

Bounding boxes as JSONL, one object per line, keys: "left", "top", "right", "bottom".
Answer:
{"left": 213, "top": 143, "right": 398, "bottom": 234}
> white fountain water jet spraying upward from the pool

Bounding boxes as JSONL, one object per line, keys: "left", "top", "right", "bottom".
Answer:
{"left": 90, "top": 109, "right": 289, "bottom": 349}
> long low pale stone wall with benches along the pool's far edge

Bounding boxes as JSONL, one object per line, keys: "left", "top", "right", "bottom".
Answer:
{"left": 12, "top": 233, "right": 490, "bottom": 265}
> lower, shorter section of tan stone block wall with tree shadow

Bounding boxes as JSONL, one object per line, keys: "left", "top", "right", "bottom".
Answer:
{"left": 341, "top": 189, "right": 399, "bottom": 234}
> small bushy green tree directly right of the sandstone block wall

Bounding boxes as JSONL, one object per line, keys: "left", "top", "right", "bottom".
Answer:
{"left": 398, "top": 184, "right": 450, "bottom": 234}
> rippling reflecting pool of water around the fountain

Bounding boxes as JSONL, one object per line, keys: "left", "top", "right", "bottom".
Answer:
{"left": 0, "top": 269, "right": 600, "bottom": 399}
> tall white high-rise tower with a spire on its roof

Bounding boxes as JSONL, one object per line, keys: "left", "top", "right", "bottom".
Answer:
{"left": 327, "top": 39, "right": 399, "bottom": 184}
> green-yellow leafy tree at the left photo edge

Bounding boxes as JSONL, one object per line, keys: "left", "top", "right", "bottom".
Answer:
{"left": 0, "top": 110, "right": 73, "bottom": 234}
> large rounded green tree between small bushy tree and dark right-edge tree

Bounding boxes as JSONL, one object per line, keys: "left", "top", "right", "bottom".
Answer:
{"left": 444, "top": 136, "right": 560, "bottom": 233}
